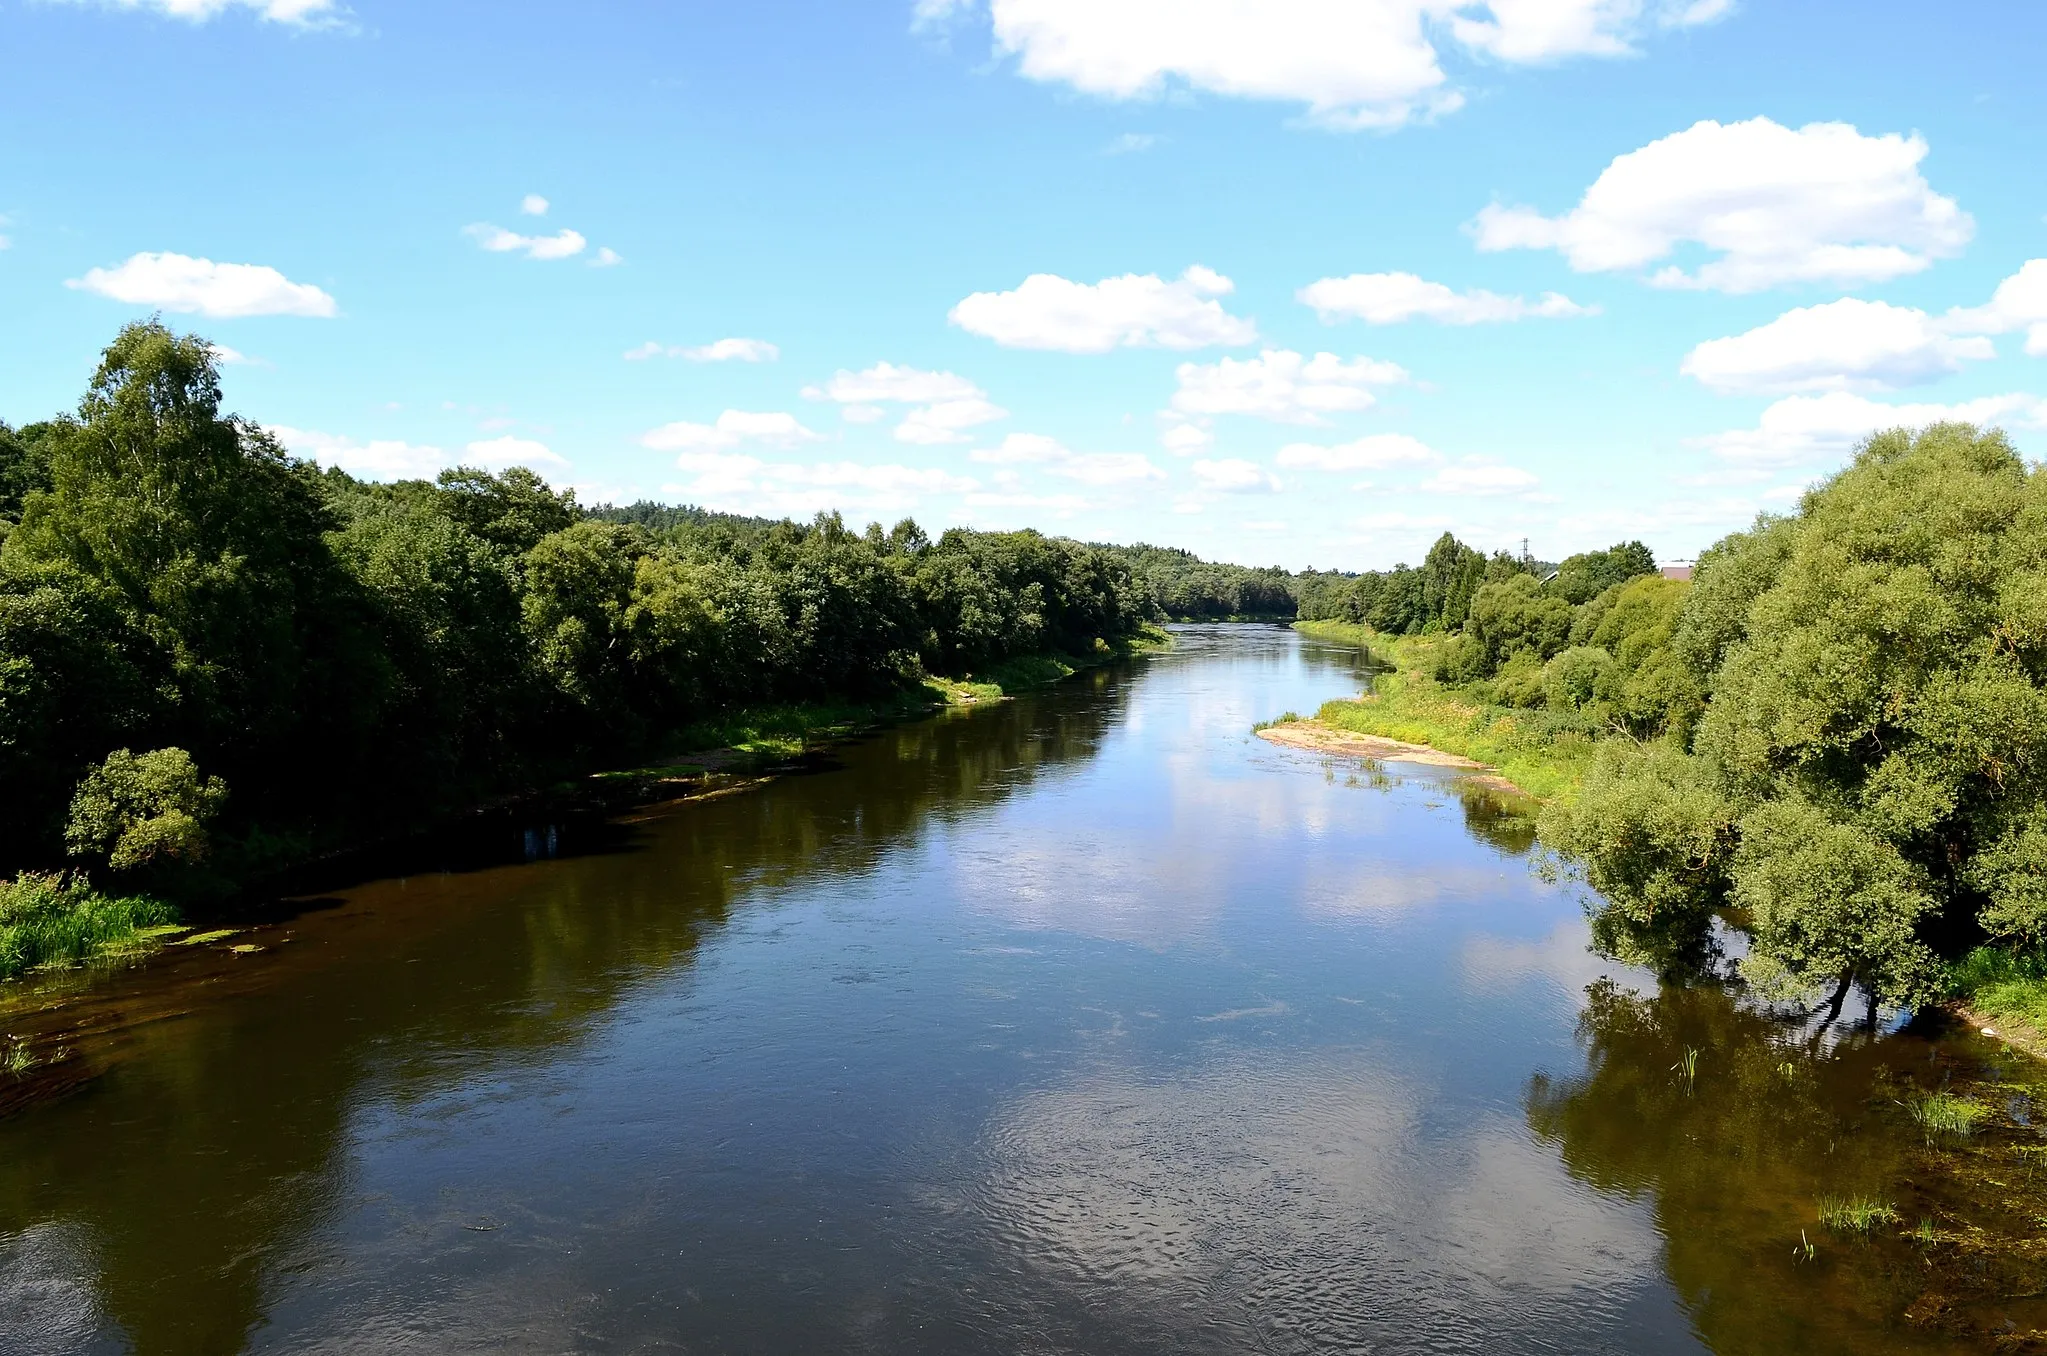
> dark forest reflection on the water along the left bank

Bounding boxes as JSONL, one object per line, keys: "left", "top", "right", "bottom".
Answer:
{"left": 0, "top": 668, "right": 1134, "bottom": 1356}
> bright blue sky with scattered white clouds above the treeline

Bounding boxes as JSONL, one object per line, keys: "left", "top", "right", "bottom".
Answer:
{"left": 0, "top": 0, "right": 2047, "bottom": 569}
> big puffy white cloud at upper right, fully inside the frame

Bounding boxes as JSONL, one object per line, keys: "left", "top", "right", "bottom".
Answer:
{"left": 1474, "top": 117, "right": 1975, "bottom": 293}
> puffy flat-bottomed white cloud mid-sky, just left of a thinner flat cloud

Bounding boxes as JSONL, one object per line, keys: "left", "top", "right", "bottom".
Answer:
{"left": 950, "top": 264, "right": 1259, "bottom": 352}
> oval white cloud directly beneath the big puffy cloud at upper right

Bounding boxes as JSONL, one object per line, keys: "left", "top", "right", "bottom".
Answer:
{"left": 1679, "top": 297, "right": 1998, "bottom": 395}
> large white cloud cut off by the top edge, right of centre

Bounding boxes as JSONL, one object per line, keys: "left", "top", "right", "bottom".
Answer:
{"left": 937, "top": 0, "right": 1730, "bottom": 131}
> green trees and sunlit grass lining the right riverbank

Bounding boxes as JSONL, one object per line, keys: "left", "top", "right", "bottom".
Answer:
{"left": 1300, "top": 424, "right": 2047, "bottom": 1016}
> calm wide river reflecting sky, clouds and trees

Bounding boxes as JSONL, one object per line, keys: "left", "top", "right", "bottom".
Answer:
{"left": 0, "top": 627, "right": 2041, "bottom": 1356}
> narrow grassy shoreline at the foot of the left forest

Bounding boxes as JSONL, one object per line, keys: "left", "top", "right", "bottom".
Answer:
{"left": 0, "top": 627, "right": 1173, "bottom": 995}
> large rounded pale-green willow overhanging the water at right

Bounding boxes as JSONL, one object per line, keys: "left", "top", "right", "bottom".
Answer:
{"left": 1548, "top": 424, "right": 2047, "bottom": 1010}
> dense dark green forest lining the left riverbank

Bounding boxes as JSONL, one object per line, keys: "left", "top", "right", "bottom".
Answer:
{"left": 0, "top": 322, "right": 1159, "bottom": 973}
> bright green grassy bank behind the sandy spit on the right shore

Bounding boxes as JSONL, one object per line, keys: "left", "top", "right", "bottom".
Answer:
{"left": 1294, "top": 621, "right": 1597, "bottom": 801}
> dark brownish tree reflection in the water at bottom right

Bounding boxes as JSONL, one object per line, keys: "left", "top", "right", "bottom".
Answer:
{"left": 1527, "top": 981, "right": 2047, "bottom": 1356}
